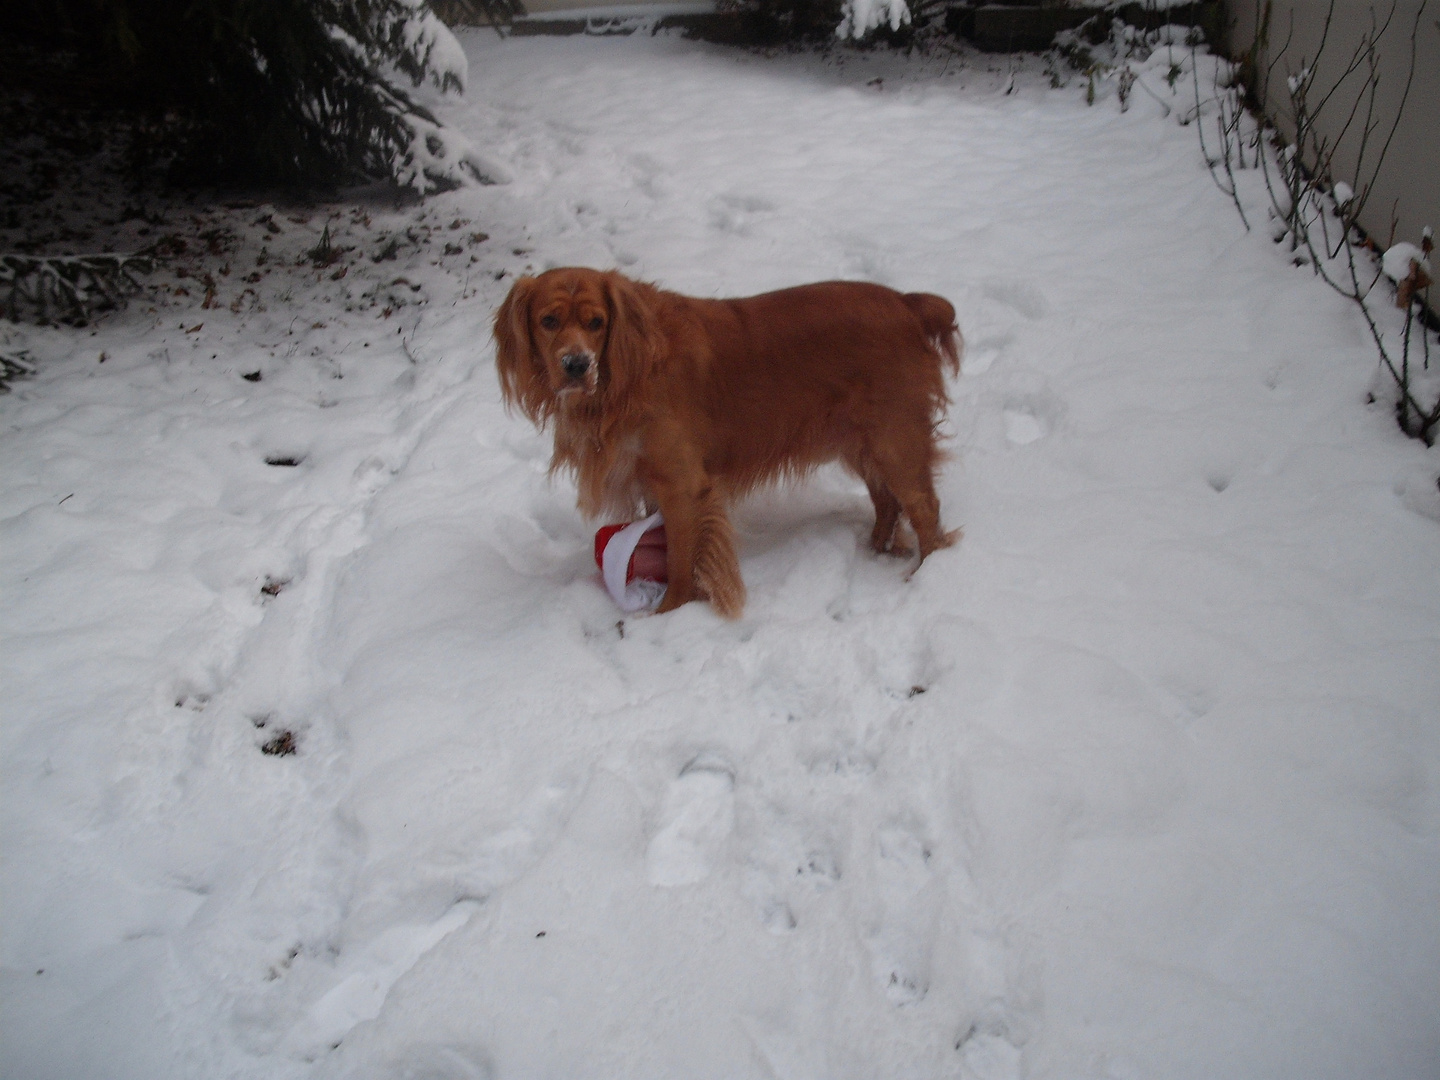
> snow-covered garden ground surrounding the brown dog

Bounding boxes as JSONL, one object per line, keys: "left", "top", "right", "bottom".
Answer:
{"left": 0, "top": 25, "right": 1440, "bottom": 1080}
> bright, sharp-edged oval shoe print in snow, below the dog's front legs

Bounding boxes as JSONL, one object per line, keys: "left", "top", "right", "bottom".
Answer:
{"left": 645, "top": 752, "right": 734, "bottom": 888}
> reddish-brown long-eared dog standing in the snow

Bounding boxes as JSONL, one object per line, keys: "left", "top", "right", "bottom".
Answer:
{"left": 495, "top": 268, "right": 960, "bottom": 618}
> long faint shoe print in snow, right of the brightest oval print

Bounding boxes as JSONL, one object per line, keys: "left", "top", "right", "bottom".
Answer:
{"left": 865, "top": 825, "right": 942, "bottom": 1005}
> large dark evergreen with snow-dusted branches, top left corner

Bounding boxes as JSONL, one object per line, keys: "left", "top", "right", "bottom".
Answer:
{"left": 28, "top": 0, "right": 508, "bottom": 193}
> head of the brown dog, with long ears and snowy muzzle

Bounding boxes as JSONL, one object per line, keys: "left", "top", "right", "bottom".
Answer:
{"left": 495, "top": 266, "right": 657, "bottom": 426}
